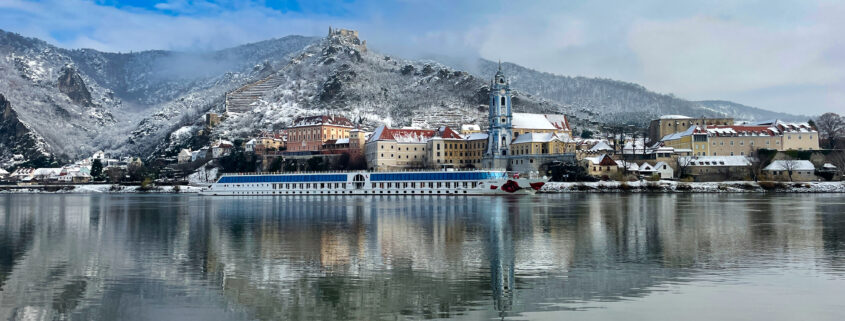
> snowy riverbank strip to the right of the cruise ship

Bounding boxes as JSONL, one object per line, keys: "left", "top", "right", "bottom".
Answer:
{"left": 540, "top": 181, "right": 845, "bottom": 193}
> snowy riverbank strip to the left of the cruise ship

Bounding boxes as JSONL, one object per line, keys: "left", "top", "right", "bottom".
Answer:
{"left": 0, "top": 184, "right": 202, "bottom": 193}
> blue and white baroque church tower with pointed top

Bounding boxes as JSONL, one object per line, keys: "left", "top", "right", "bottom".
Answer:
{"left": 486, "top": 62, "right": 513, "bottom": 158}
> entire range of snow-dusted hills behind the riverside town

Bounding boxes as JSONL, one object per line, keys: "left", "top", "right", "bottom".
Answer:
{"left": 0, "top": 26, "right": 806, "bottom": 162}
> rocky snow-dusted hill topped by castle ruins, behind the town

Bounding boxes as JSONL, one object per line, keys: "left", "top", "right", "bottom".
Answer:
{"left": 198, "top": 29, "right": 565, "bottom": 145}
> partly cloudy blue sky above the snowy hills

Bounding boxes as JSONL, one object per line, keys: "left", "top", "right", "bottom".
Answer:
{"left": 0, "top": 0, "right": 845, "bottom": 114}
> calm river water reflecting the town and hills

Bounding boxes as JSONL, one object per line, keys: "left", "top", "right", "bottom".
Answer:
{"left": 0, "top": 194, "right": 845, "bottom": 320}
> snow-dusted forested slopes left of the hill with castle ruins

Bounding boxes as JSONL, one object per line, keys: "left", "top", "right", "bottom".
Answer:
{"left": 0, "top": 31, "right": 316, "bottom": 161}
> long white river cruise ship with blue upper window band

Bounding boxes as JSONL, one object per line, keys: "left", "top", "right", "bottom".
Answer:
{"left": 200, "top": 170, "right": 548, "bottom": 196}
